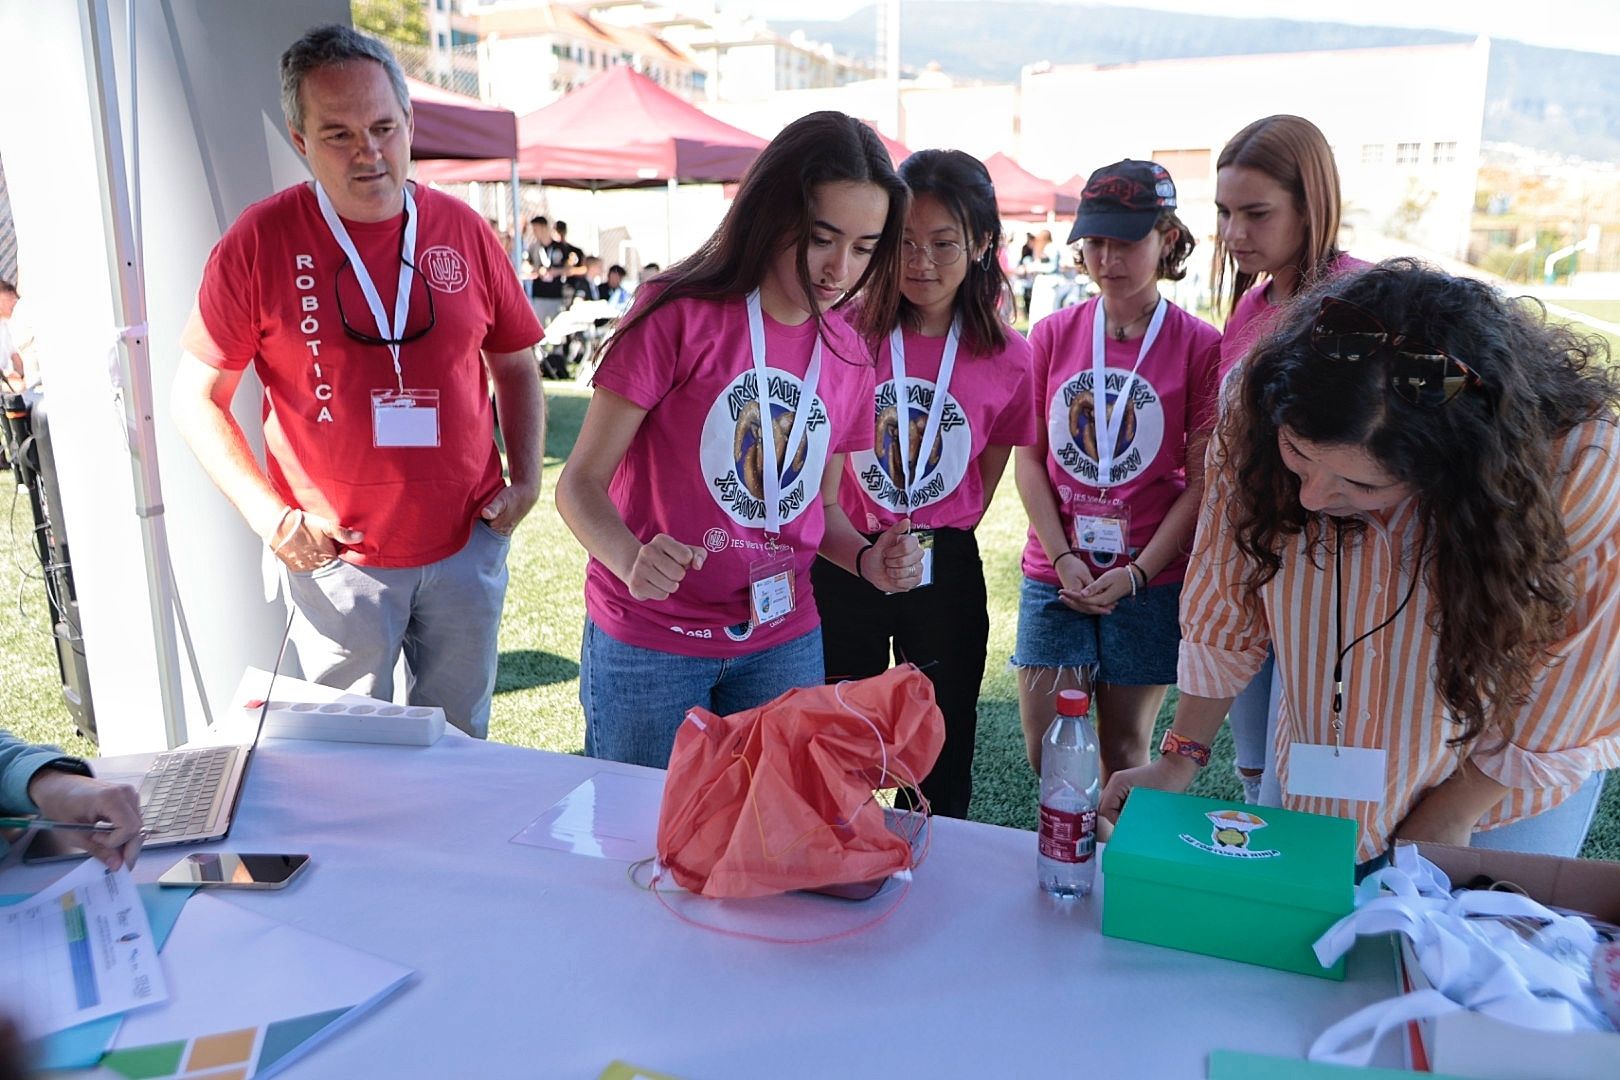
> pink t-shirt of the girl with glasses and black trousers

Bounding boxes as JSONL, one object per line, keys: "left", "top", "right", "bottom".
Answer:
{"left": 838, "top": 327, "right": 1037, "bottom": 533}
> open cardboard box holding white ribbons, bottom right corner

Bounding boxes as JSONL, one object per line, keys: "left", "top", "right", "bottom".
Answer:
{"left": 1393, "top": 841, "right": 1620, "bottom": 1080}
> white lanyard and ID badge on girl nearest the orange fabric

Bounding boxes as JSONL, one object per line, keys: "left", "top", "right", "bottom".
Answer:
{"left": 748, "top": 290, "right": 821, "bottom": 627}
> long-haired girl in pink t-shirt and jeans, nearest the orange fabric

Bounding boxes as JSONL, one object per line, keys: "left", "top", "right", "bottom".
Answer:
{"left": 557, "top": 112, "right": 922, "bottom": 767}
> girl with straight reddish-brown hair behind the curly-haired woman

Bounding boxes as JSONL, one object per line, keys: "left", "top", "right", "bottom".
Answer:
{"left": 1215, "top": 115, "right": 1367, "bottom": 805}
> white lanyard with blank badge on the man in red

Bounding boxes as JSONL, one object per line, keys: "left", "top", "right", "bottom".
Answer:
{"left": 314, "top": 181, "right": 439, "bottom": 449}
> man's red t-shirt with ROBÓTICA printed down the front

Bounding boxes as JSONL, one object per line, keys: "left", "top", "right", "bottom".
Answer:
{"left": 181, "top": 183, "right": 539, "bottom": 567}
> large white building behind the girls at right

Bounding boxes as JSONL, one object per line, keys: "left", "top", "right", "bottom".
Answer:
{"left": 1017, "top": 39, "right": 1490, "bottom": 259}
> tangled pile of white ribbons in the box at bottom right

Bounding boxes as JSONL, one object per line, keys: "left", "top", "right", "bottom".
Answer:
{"left": 1309, "top": 848, "right": 1612, "bottom": 1065}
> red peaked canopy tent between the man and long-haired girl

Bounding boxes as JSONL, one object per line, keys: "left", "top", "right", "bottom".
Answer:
{"left": 418, "top": 66, "right": 765, "bottom": 189}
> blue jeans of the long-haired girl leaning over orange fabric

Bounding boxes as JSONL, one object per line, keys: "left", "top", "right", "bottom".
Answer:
{"left": 580, "top": 619, "right": 823, "bottom": 769}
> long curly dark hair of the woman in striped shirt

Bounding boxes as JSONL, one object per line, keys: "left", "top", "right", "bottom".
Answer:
{"left": 1218, "top": 259, "right": 1620, "bottom": 745}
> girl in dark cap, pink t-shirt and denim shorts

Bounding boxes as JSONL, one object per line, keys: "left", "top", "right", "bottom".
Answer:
{"left": 1013, "top": 160, "right": 1220, "bottom": 776}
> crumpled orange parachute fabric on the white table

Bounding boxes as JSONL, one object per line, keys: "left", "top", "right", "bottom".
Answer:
{"left": 658, "top": 664, "right": 944, "bottom": 897}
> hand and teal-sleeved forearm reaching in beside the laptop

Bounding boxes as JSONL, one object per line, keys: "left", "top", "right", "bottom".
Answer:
{"left": 0, "top": 730, "right": 141, "bottom": 870}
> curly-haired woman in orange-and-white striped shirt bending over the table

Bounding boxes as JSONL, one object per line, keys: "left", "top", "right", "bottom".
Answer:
{"left": 1102, "top": 261, "right": 1620, "bottom": 860}
